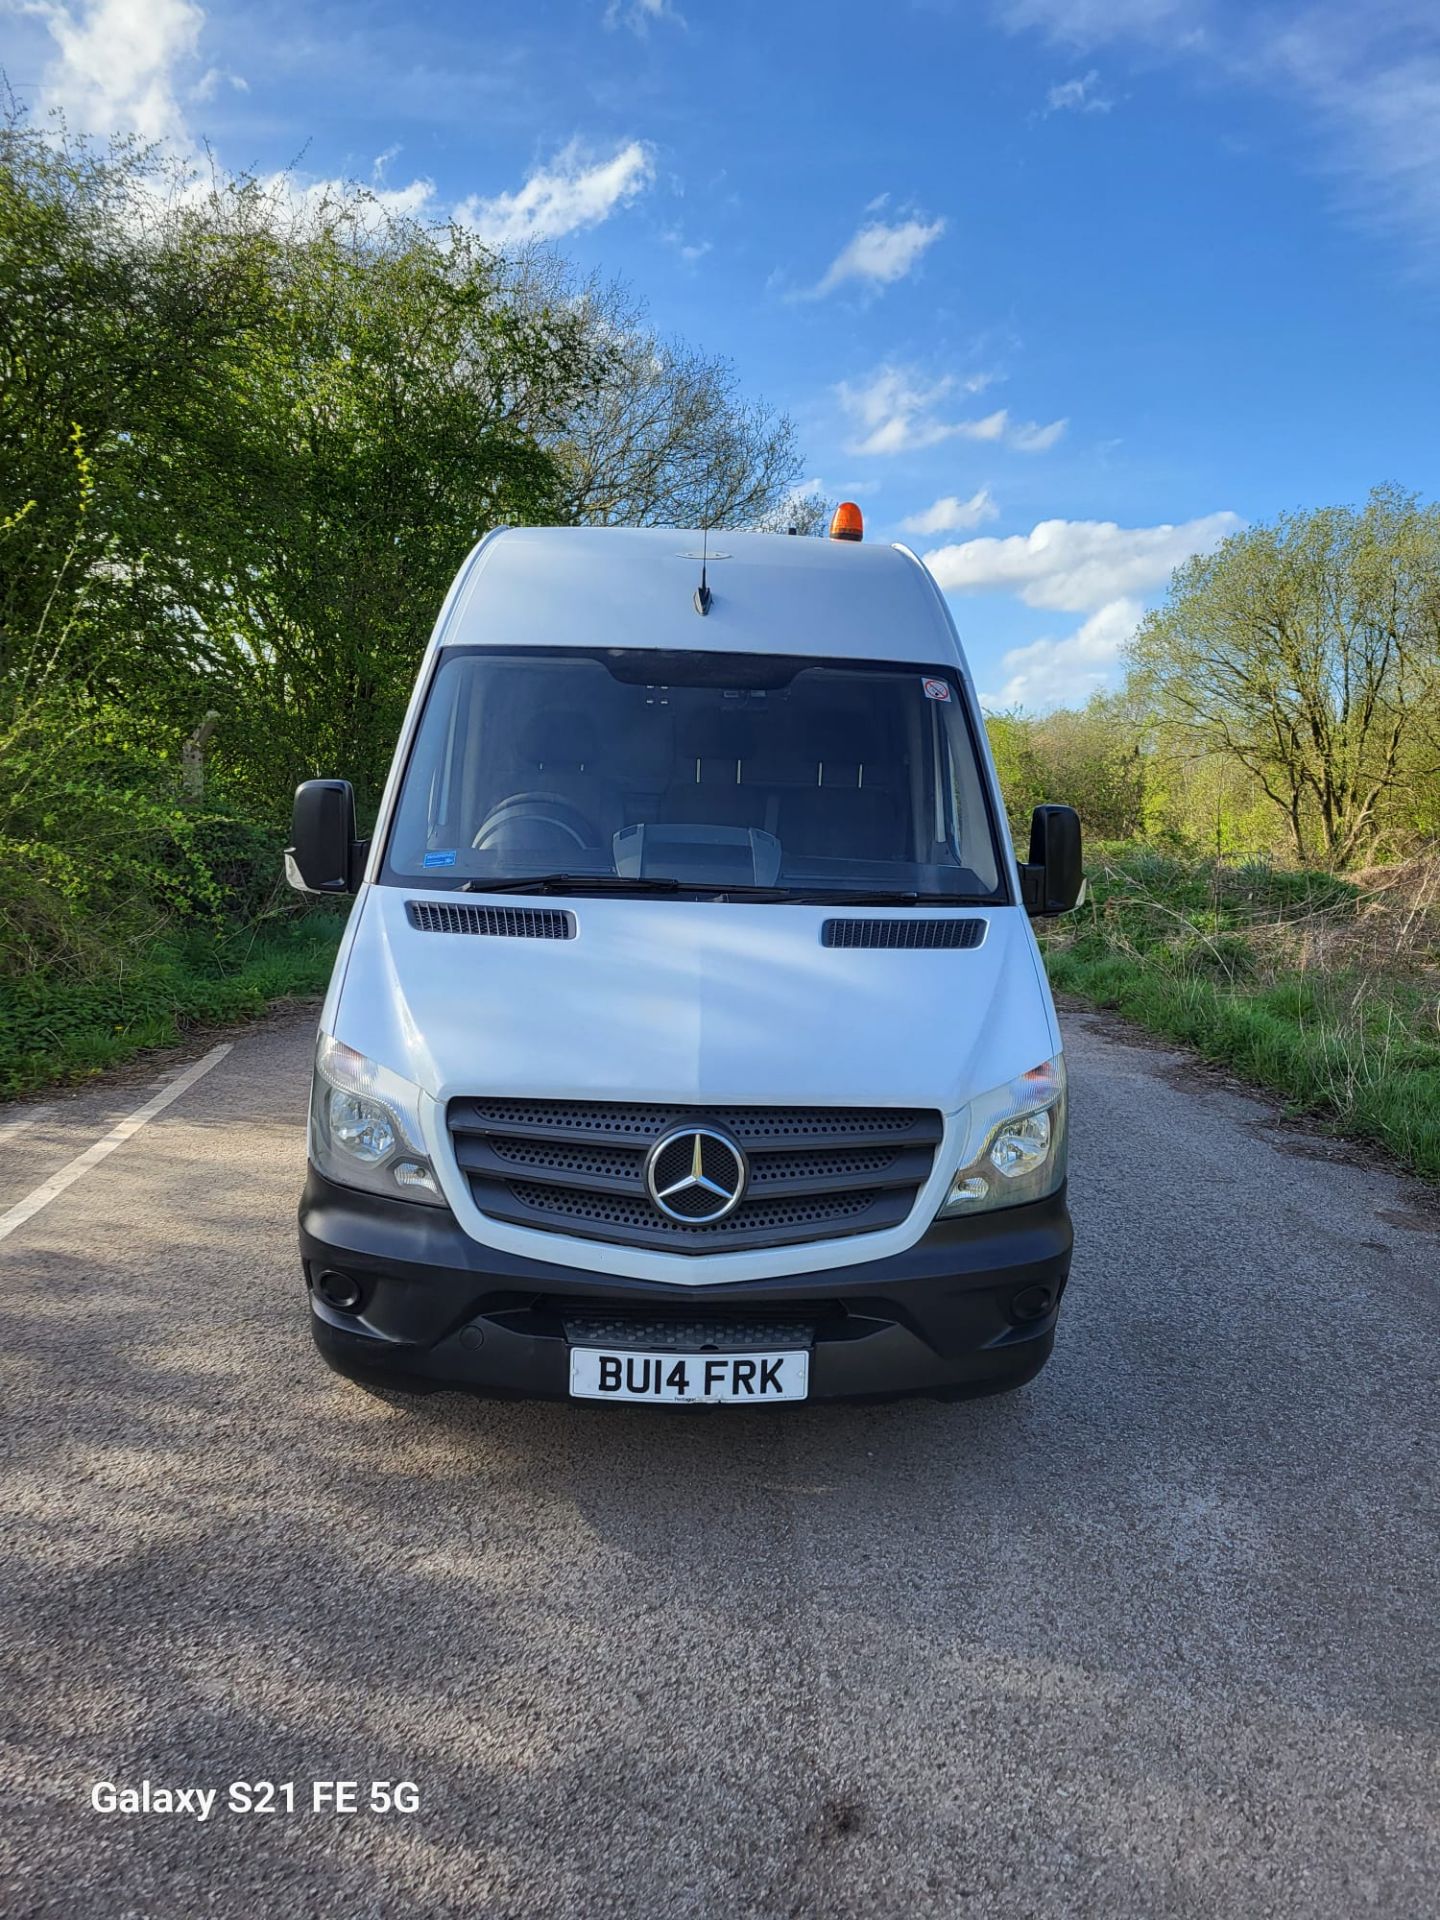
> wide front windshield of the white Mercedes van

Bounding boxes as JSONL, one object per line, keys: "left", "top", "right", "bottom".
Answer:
{"left": 382, "top": 647, "right": 1004, "bottom": 900}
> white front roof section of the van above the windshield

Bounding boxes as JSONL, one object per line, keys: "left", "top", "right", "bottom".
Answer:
{"left": 436, "top": 526, "right": 964, "bottom": 668}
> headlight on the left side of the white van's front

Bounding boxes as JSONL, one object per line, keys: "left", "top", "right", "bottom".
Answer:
{"left": 309, "top": 1033, "right": 445, "bottom": 1206}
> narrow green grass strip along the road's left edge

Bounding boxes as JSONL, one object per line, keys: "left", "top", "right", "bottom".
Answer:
{"left": 0, "top": 912, "right": 344, "bottom": 1098}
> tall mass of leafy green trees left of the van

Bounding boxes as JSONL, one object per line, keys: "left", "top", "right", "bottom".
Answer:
{"left": 0, "top": 119, "right": 601, "bottom": 820}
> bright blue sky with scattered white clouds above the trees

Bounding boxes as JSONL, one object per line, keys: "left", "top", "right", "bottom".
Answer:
{"left": 0, "top": 0, "right": 1440, "bottom": 708}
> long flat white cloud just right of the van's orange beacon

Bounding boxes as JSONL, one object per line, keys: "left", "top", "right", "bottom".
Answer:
{"left": 924, "top": 513, "right": 1242, "bottom": 612}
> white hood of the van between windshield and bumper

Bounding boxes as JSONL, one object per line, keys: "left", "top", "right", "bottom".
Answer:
{"left": 323, "top": 885, "right": 1060, "bottom": 1281}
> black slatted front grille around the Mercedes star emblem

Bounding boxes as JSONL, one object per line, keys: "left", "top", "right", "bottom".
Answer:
{"left": 447, "top": 1100, "right": 941, "bottom": 1254}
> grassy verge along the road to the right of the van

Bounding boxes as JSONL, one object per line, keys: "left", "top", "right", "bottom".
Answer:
{"left": 1043, "top": 849, "right": 1440, "bottom": 1181}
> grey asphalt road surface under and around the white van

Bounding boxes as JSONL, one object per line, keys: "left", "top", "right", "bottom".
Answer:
{"left": 0, "top": 1016, "right": 1440, "bottom": 1920}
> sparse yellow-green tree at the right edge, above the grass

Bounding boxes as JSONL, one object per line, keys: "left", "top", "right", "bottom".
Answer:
{"left": 1131, "top": 488, "right": 1440, "bottom": 866}
